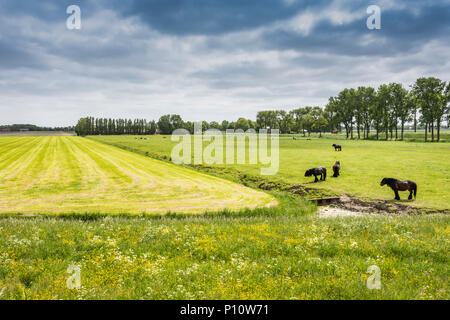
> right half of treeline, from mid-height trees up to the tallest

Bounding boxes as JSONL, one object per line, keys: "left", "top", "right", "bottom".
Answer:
{"left": 256, "top": 78, "right": 450, "bottom": 141}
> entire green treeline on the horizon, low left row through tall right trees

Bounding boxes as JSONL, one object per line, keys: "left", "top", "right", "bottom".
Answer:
{"left": 75, "top": 78, "right": 450, "bottom": 141}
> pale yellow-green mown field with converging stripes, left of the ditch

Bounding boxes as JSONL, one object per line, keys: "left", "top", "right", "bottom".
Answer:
{"left": 0, "top": 137, "right": 276, "bottom": 214}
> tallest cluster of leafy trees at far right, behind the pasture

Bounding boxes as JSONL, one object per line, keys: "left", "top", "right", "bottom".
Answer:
{"left": 324, "top": 78, "right": 450, "bottom": 141}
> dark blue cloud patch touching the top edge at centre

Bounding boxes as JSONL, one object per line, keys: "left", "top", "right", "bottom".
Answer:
{"left": 124, "top": 0, "right": 327, "bottom": 35}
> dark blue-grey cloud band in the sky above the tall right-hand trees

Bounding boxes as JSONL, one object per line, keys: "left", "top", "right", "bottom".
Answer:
{"left": 264, "top": 4, "right": 450, "bottom": 56}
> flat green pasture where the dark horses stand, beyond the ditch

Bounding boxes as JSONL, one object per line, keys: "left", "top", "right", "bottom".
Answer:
{"left": 90, "top": 135, "right": 450, "bottom": 210}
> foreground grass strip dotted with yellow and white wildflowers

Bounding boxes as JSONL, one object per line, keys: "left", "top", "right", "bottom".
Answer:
{"left": 0, "top": 215, "right": 450, "bottom": 299}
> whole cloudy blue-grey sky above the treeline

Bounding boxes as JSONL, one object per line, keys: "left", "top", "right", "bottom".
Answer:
{"left": 0, "top": 0, "right": 450, "bottom": 126}
